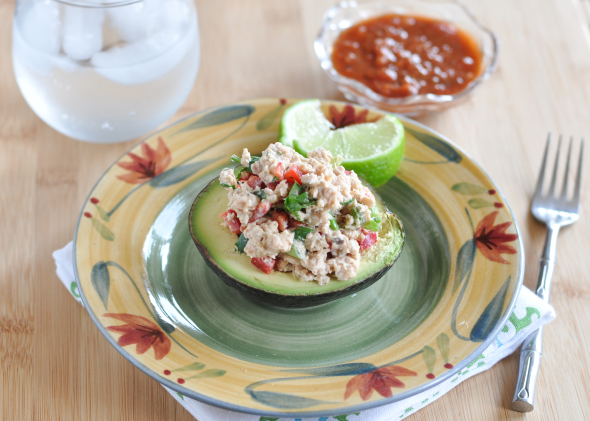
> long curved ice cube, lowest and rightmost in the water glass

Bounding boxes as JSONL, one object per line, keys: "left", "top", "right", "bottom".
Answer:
{"left": 91, "top": 22, "right": 198, "bottom": 85}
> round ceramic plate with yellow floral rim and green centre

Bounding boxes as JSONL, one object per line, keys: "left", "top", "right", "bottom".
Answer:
{"left": 74, "top": 99, "right": 524, "bottom": 417}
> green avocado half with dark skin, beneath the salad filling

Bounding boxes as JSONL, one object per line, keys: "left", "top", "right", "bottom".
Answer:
{"left": 188, "top": 178, "right": 405, "bottom": 308}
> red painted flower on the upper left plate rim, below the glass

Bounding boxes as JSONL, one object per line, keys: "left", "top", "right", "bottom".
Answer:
{"left": 117, "top": 137, "right": 172, "bottom": 184}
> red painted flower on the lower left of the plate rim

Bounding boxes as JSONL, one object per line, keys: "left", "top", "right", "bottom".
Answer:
{"left": 104, "top": 313, "right": 172, "bottom": 360}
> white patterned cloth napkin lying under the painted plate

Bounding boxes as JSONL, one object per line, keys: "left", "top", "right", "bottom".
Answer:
{"left": 53, "top": 243, "right": 555, "bottom": 421}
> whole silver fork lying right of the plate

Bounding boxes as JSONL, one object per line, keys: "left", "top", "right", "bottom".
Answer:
{"left": 512, "top": 134, "right": 584, "bottom": 412}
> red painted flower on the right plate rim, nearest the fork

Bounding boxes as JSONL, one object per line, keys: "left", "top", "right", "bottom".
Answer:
{"left": 475, "top": 211, "right": 518, "bottom": 264}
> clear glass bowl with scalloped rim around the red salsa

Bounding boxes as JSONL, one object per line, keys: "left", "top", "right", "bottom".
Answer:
{"left": 314, "top": 0, "right": 498, "bottom": 116}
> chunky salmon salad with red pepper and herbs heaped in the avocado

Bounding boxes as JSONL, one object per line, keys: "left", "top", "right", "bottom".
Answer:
{"left": 219, "top": 143, "right": 381, "bottom": 285}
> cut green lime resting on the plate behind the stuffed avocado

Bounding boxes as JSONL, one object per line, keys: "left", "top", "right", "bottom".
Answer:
{"left": 279, "top": 99, "right": 405, "bottom": 186}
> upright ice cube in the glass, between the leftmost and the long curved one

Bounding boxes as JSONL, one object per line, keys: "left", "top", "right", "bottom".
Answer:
{"left": 63, "top": 5, "right": 104, "bottom": 60}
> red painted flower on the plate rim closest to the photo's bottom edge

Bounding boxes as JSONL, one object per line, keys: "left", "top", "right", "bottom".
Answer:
{"left": 344, "top": 365, "right": 418, "bottom": 401}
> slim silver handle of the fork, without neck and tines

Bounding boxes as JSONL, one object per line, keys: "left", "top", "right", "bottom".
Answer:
{"left": 511, "top": 226, "right": 559, "bottom": 412}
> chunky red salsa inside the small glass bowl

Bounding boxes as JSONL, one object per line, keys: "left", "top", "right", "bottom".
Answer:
{"left": 332, "top": 14, "right": 482, "bottom": 98}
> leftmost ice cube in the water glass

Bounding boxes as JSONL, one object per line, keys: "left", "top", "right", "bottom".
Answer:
{"left": 17, "top": 0, "right": 61, "bottom": 54}
